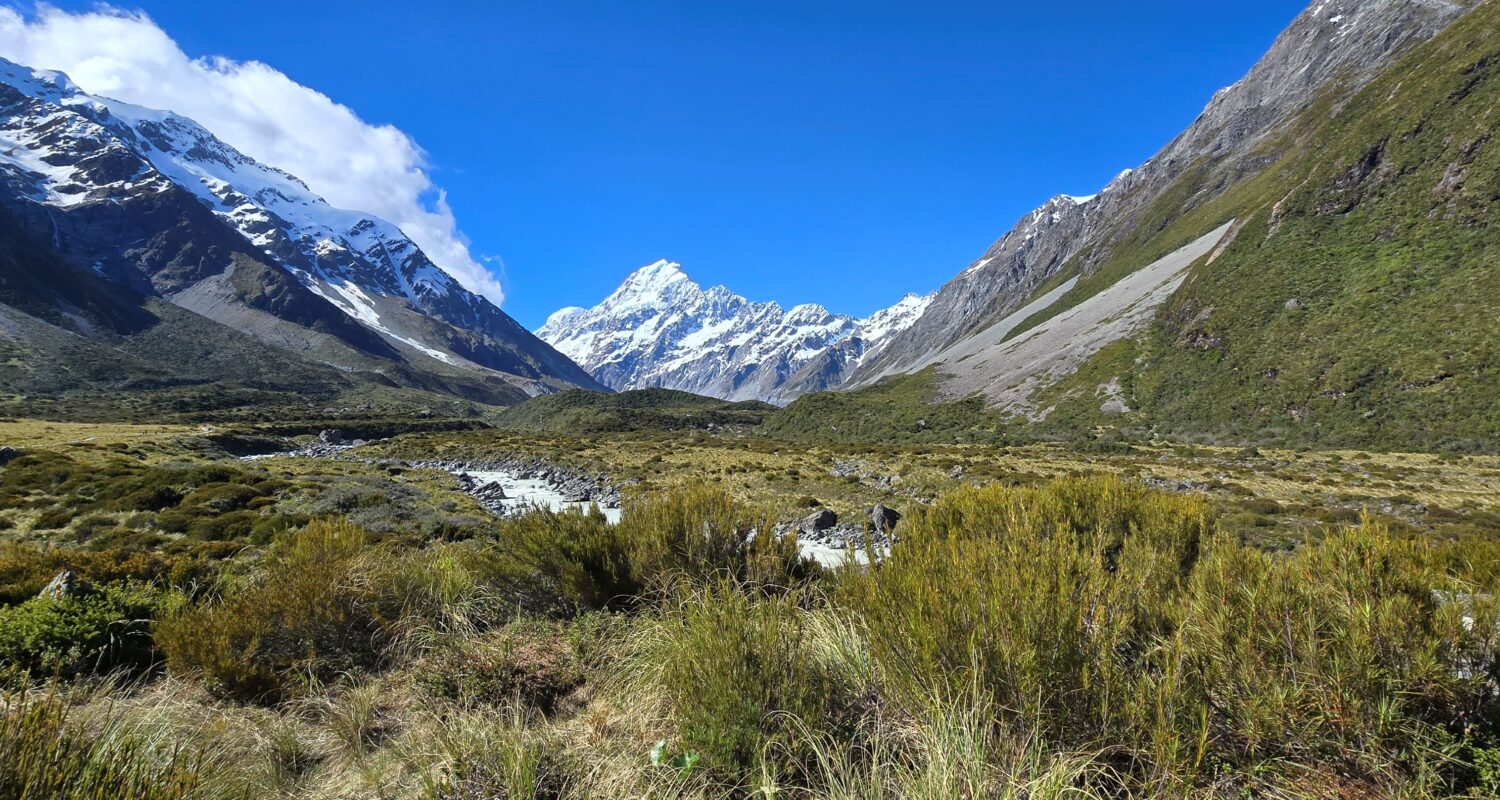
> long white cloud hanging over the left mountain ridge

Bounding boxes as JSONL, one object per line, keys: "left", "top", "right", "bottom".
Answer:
{"left": 0, "top": 6, "right": 504, "bottom": 303}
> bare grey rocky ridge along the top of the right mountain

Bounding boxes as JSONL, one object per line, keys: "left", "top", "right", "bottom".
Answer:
{"left": 849, "top": 0, "right": 1475, "bottom": 386}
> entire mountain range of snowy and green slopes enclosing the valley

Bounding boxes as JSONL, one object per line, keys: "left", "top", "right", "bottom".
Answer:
{"left": 0, "top": 0, "right": 1500, "bottom": 449}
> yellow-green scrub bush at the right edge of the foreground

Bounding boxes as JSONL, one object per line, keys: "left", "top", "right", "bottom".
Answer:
{"left": 1167, "top": 522, "right": 1500, "bottom": 774}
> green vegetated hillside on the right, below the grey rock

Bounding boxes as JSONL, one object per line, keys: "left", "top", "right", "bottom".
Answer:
{"left": 960, "top": 3, "right": 1500, "bottom": 450}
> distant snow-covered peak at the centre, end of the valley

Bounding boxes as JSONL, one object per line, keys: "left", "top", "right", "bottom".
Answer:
{"left": 537, "top": 261, "right": 929, "bottom": 402}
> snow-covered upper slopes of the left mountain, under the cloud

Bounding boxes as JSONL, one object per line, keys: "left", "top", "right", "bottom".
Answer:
{"left": 0, "top": 59, "right": 593, "bottom": 386}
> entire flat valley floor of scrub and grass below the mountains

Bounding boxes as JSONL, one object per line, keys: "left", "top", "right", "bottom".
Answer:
{"left": 0, "top": 420, "right": 1500, "bottom": 800}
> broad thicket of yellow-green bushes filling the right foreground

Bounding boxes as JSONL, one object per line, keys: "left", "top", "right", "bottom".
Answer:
{"left": 836, "top": 479, "right": 1500, "bottom": 792}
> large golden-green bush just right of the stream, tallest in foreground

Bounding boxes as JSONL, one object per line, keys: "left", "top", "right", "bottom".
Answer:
{"left": 839, "top": 479, "right": 1208, "bottom": 740}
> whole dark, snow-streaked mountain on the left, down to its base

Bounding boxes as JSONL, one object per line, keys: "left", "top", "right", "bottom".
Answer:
{"left": 0, "top": 60, "right": 603, "bottom": 417}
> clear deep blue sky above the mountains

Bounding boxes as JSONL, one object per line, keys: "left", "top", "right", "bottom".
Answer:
{"left": 33, "top": 0, "right": 1304, "bottom": 327}
